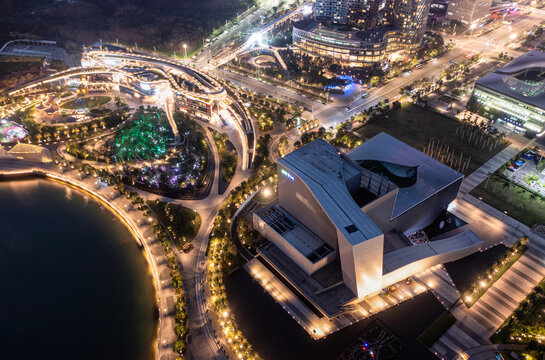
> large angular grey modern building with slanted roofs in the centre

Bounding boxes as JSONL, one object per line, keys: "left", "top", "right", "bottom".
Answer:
{"left": 253, "top": 133, "right": 482, "bottom": 316}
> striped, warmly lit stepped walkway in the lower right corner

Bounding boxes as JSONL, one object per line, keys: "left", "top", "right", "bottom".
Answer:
{"left": 431, "top": 236, "right": 545, "bottom": 359}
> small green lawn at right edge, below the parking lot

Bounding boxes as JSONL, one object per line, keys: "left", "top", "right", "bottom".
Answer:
{"left": 470, "top": 175, "right": 545, "bottom": 227}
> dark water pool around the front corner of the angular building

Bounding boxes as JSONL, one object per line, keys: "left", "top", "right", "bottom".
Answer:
{"left": 225, "top": 268, "right": 444, "bottom": 360}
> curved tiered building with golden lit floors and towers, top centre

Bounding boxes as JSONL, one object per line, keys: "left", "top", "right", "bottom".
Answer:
{"left": 293, "top": 0, "right": 430, "bottom": 66}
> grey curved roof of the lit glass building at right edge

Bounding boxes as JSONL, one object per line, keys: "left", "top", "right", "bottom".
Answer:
{"left": 476, "top": 50, "right": 545, "bottom": 109}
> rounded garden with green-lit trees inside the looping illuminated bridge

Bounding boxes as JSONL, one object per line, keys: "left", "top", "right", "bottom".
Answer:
{"left": 111, "top": 108, "right": 209, "bottom": 196}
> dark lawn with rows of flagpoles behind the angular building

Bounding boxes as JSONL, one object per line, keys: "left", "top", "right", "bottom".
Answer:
{"left": 358, "top": 105, "right": 508, "bottom": 175}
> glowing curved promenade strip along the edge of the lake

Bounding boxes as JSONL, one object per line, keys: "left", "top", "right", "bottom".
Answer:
{"left": 0, "top": 169, "right": 164, "bottom": 360}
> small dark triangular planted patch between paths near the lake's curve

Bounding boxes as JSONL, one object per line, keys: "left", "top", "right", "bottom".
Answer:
{"left": 146, "top": 200, "right": 202, "bottom": 249}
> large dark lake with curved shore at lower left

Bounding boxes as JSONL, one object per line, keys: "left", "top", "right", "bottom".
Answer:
{"left": 0, "top": 180, "right": 157, "bottom": 360}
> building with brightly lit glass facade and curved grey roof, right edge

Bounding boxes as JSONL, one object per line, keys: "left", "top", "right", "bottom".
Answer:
{"left": 468, "top": 50, "right": 545, "bottom": 132}
